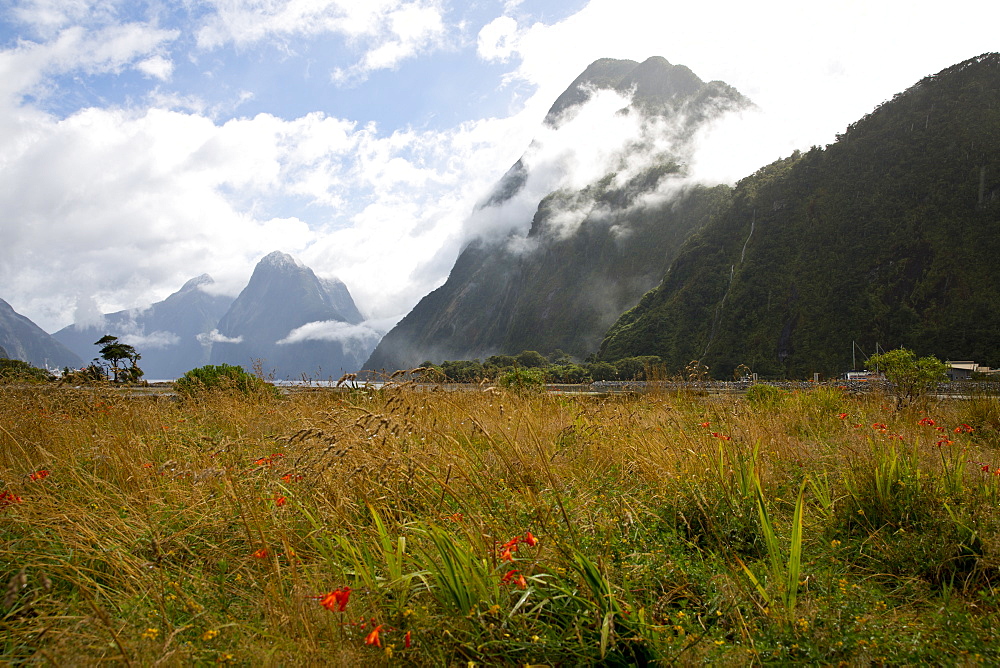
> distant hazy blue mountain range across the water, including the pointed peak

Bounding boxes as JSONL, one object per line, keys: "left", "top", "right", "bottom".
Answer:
{"left": 46, "top": 252, "right": 377, "bottom": 380}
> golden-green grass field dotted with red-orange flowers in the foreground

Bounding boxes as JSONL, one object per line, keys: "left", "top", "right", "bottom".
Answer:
{"left": 0, "top": 378, "right": 1000, "bottom": 666}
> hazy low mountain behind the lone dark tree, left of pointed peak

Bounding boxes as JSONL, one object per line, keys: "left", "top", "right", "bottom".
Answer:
{"left": 53, "top": 274, "right": 233, "bottom": 380}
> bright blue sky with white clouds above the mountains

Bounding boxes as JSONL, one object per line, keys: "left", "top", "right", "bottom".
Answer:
{"left": 0, "top": 0, "right": 1000, "bottom": 332}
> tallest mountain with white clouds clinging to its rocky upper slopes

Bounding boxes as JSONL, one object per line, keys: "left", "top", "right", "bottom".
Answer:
{"left": 364, "top": 57, "right": 751, "bottom": 371}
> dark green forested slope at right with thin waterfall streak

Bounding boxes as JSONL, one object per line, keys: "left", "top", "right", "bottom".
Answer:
{"left": 600, "top": 54, "right": 1000, "bottom": 377}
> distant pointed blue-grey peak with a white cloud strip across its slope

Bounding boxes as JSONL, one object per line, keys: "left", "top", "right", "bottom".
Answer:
{"left": 209, "top": 252, "right": 377, "bottom": 379}
